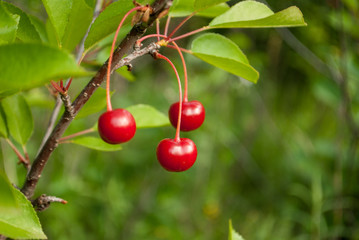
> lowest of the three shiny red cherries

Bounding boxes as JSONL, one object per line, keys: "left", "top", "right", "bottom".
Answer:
{"left": 157, "top": 138, "right": 197, "bottom": 172}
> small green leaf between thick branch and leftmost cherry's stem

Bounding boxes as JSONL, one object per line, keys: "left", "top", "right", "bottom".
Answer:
{"left": 76, "top": 88, "right": 106, "bottom": 118}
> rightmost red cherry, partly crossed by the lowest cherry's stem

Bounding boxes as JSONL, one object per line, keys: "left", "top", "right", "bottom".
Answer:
{"left": 168, "top": 100, "right": 205, "bottom": 132}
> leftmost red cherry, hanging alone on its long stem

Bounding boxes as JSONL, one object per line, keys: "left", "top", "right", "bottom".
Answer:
{"left": 98, "top": 109, "right": 136, "bottom": 144}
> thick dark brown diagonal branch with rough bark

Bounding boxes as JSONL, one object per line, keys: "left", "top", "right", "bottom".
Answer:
{"left": 21, "top": 0, "right": 172, "bottom": 199}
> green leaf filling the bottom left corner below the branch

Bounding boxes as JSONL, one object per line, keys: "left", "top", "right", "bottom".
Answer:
{"left": 0, "top": 171, "right": 47, "bottom": 239}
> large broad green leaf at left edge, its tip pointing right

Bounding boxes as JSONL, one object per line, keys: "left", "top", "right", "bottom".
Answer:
{"left": 0, "top": 43, "right": 89, "bottom": 98}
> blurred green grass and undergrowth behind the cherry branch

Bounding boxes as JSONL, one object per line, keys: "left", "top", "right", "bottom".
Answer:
{"left": 3, "top": 0, "right": 359, "bottom": 240}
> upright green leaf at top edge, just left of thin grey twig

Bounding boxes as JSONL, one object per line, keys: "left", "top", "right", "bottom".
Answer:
{"left": 61, "top": 0, "right": 93, "bottom": 51}
